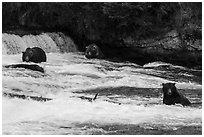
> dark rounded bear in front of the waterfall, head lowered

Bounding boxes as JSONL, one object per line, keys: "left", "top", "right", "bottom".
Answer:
{"left": 22, "top": 47, "right": 47, "bottom": 63}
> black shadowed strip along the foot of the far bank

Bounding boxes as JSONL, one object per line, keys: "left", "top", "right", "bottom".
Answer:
{"left": 2, "top": 27, "right": 202, "bottom": 70}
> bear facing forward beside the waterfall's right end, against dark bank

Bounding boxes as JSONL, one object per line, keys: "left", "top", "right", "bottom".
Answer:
{"left": 85, "top": 44, "right": 104, "bottom": 59}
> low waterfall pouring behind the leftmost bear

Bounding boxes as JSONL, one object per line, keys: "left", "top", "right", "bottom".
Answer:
{"left": 2, "top": 32, "right": 78, "bottom": 55}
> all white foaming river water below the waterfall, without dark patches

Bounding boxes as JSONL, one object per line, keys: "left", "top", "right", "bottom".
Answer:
{"left": 2, "top": 53, "right": 202, "bottom": 134}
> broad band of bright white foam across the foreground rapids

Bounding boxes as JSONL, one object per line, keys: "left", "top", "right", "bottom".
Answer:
{"left": 3, "top": 98, "right": 202, "bottom": 134}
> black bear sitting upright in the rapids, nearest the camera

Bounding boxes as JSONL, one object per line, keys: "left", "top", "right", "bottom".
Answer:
{"left": 162, "top": 83, "right": 191, "bottom": 106}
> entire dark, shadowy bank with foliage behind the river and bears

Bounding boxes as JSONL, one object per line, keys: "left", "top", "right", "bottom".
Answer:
{"left": 2, "top": 2, "right": 202, "bottom": 69}
